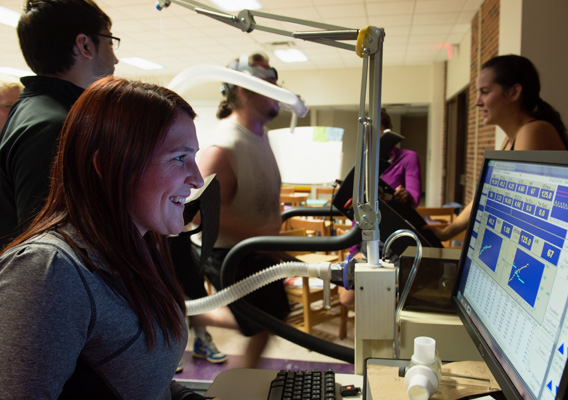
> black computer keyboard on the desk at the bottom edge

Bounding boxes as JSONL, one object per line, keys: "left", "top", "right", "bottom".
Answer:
{"left": 267, "top": 369, "right": 340, "bottom": 400}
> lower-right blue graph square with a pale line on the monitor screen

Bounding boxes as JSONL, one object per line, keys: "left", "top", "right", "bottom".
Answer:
{"left": 509, "top": 249, "right": 544, "bottom": 307}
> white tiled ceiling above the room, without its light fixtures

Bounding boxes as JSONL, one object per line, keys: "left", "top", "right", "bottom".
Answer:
{"left": 0, "top": 0, "right": 483, "bottom": 79}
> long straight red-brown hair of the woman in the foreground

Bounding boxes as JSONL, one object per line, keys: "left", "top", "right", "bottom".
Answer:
{"left": 3, "top": 77, "right": 195, "bottom": 348}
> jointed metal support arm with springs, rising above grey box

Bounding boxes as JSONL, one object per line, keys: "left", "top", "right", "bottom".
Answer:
{"left": 156, "top": 0, "right": 385, "bottom": 266}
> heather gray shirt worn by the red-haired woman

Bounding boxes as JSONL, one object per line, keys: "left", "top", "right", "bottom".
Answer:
{"left": 0, "top": 233, "right": 187, "bottom": 400}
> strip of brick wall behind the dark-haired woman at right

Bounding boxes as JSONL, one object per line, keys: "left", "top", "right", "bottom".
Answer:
{"left": 465, "top": 0, "right": 500, "bottom": 202}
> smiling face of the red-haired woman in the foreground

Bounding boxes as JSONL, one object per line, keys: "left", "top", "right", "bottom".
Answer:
{"left": 132, "top": 111, "right": 203, "bottom": 236}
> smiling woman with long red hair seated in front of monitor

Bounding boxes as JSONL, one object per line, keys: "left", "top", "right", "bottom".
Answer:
{"left": 0, "top": 77, "right": 217, "bottom": 399}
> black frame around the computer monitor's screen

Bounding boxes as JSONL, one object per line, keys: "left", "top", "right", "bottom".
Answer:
{"left": 452, "top": 150, "right": 568, "bottom": 399}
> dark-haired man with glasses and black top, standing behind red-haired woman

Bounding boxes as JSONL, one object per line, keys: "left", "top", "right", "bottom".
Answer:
{"left": 0, "top": 0, "right": 120, "bottom": 247}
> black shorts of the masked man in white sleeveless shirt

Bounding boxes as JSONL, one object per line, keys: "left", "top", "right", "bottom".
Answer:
{"left": 191, "top": 245, "right": 290, "bottom": 336}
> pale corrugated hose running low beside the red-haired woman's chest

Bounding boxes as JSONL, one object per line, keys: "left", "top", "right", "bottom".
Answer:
{"left": 185, "top": 262, "right": 331, "bottom": 316}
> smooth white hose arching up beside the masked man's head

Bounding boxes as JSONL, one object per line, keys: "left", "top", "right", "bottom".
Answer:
{"left": 168, "top": 64, "right": 308, "bottom": 118}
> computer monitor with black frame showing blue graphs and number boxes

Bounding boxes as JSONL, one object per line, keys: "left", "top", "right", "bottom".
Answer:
{"left": 453, "top": 151, "right": 568, "bottom": 399}
